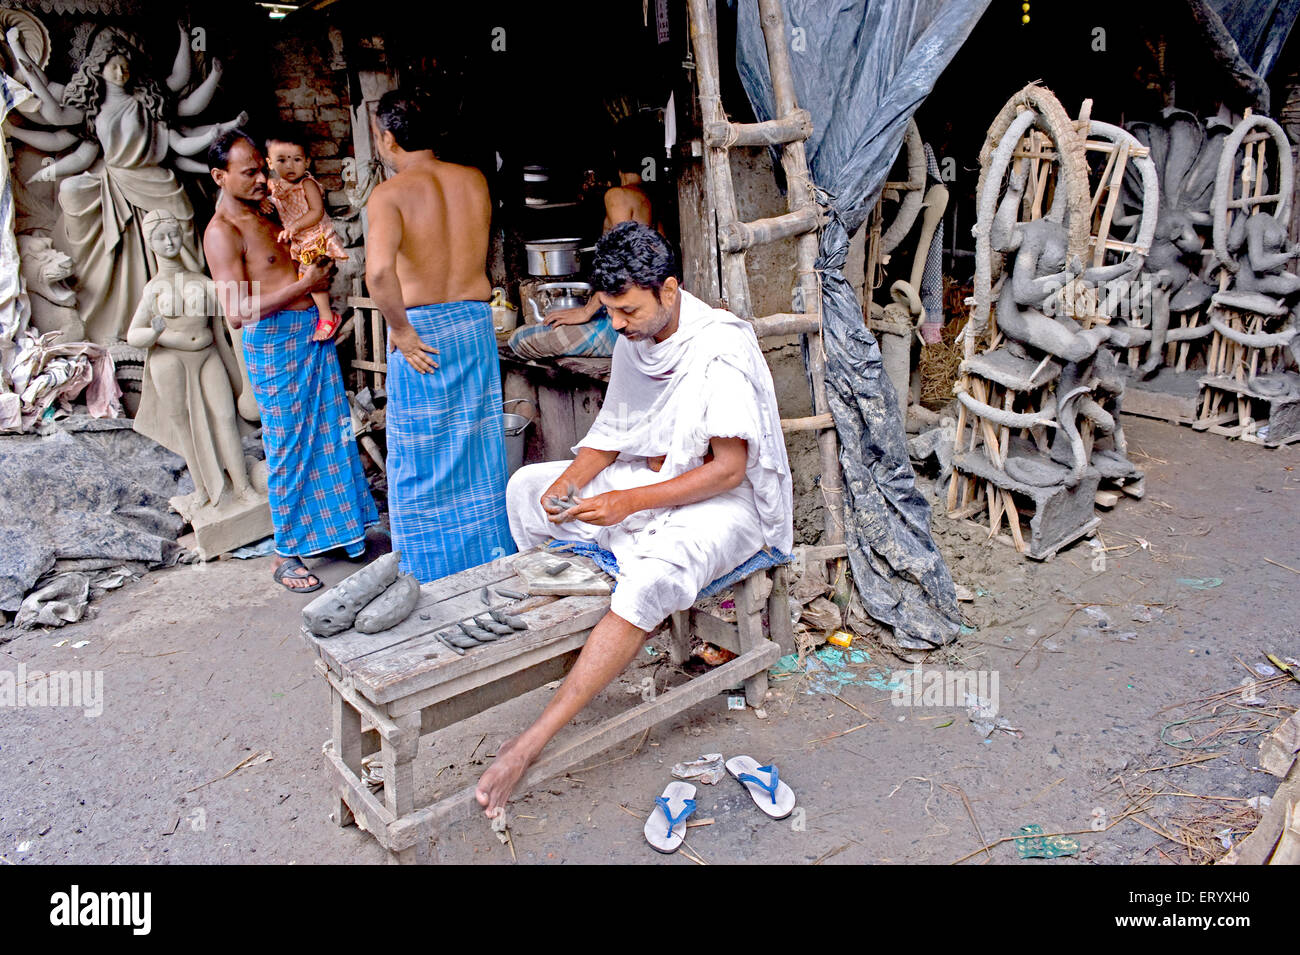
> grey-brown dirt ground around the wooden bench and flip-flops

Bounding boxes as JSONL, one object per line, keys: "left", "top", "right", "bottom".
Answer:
{"left": 0, "top": 418, "right": 1300, "bottom": 865}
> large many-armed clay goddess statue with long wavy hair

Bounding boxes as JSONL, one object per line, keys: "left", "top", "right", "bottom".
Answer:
{"left": 7, "top": 27, "right": 246, "bottom": 342}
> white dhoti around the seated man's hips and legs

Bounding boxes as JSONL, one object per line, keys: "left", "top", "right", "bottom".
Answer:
{"left": 506, "top": 460, "right": 764, "bottom": 630}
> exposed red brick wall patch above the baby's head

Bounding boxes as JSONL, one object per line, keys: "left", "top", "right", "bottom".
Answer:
{"left": 272, "top": 23, "right": 352, "bottom": 200}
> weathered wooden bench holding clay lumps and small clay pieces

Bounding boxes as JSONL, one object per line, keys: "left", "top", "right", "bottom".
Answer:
{"left": 303, "top": 540, "right": 793, "bottom": 863}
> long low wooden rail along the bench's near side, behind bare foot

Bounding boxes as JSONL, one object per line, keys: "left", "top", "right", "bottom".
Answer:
{"left": 386, "top": 641, "right": 781, "bottom": 850}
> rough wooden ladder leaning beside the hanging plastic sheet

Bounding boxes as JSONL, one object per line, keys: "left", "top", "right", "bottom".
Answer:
{"left": 689, "top": 0, "right": 848, "bottom": 560}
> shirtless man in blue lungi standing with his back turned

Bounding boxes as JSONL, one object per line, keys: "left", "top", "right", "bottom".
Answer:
{"left": 365, "top": 91, "right": 515, "bottom": 583}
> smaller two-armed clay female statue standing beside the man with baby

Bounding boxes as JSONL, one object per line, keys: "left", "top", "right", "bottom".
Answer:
{"left": 126, "top": 210, "right": 257, "bottom": 508}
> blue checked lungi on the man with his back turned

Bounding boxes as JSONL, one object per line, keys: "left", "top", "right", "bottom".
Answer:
{"left": 386, "top": 301, "right": 515, "bottom": 583}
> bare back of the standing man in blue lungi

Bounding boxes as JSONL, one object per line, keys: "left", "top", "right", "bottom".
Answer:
{"left": 369, "top": 157, "right": 491, "bottom": 308}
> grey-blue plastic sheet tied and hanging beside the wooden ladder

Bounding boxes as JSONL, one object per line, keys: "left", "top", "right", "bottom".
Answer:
{"left": 736, "top": 0, "right": 988, "bottom": 648}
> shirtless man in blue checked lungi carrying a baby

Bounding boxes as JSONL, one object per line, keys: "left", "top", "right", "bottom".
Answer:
{"left": 203, "top": 130, "right": 378, "bottom": 592}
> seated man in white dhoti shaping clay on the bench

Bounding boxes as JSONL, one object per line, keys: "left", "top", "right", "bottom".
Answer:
{"left": 476, "top": 222, "right": 794, "bottom": 816}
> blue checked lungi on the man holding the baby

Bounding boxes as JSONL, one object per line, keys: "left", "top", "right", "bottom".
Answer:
{"left": 243, "top": 308, "right": 380, "bottom": 557}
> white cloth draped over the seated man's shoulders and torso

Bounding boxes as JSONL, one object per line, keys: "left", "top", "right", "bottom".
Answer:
{"left": 575, "top": 288, "right": 794, "bottom": 553}
